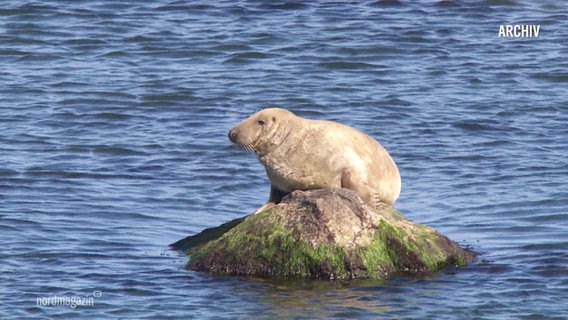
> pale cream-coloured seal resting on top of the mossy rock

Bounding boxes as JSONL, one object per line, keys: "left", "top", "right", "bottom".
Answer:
{"left": 229, "top": 108, "right": 401, "bottom": 213}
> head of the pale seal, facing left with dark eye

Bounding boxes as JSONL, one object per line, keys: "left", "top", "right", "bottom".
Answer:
{"left": 229, "top": 108, "right": 298, "bottom": 156}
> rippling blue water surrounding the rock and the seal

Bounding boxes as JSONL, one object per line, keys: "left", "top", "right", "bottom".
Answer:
{"left": 0, "top": 0, "right": 568, "bottom": 319}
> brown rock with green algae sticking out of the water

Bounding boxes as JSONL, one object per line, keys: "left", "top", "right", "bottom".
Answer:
{"left": 172, "top": 189, "right": 476, "bottom": 279}
